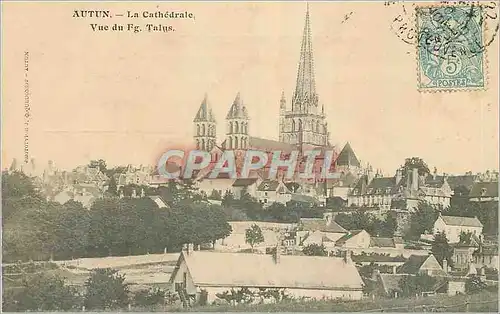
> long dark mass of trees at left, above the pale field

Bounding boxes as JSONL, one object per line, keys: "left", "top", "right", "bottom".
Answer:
{"left": 2, "top": 173, "right": 231, "bottom": 262}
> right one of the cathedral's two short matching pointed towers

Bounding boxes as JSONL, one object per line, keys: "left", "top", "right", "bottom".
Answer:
{"left": 225, "top": 93, "right": 249, "bottom": 149}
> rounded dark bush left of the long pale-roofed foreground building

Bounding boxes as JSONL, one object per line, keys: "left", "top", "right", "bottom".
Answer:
{"left": 84, "top": 268, "right": 129, "bottom": 310}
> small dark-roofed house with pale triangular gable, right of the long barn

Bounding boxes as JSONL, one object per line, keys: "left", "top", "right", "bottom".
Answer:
{"left": 397, "top": 254, "right": 448, "bottom": 276}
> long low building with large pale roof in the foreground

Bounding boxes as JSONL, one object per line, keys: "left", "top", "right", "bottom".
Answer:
{"left": 170, "top": 247, "right": 363, "bottom": 303}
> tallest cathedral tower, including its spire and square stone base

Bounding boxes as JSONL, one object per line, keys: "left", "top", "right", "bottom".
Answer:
{"left": 279, "top": 6, "right": 329, "bottom": 146}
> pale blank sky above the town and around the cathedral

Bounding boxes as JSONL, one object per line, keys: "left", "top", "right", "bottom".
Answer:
{"left": 2, "top": 2, "right": 499, "bottom": 175}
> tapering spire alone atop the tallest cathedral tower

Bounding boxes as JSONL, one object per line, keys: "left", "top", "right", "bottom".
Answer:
{"left": 294, "top": 4, "right": 318, "bottom": 109}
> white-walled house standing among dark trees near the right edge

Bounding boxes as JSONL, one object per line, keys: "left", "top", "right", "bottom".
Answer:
{"left": 433, "top": 214, "right": 483, "bottom": 243}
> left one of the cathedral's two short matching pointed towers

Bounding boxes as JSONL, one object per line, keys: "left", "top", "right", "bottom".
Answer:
{"left": 193, "top": 94, "right": 217, "bottom": 151}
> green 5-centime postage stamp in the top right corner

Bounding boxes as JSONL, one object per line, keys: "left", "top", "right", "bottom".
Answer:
{"left": 416, "top": 5, "right": 485, "bottom": 90}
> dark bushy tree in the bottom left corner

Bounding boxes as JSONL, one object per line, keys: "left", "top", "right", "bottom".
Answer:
{"left": 3, "top": 273, "right": 81, "bottom": 312}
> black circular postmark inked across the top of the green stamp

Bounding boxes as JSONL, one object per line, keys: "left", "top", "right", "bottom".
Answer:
{"left": 384, "top": 1, "right": 499, "bottom": 59}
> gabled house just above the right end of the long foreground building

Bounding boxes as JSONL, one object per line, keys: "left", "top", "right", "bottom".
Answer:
{"left": 297, "top": 215, "right": 348, "bottom": 246}
